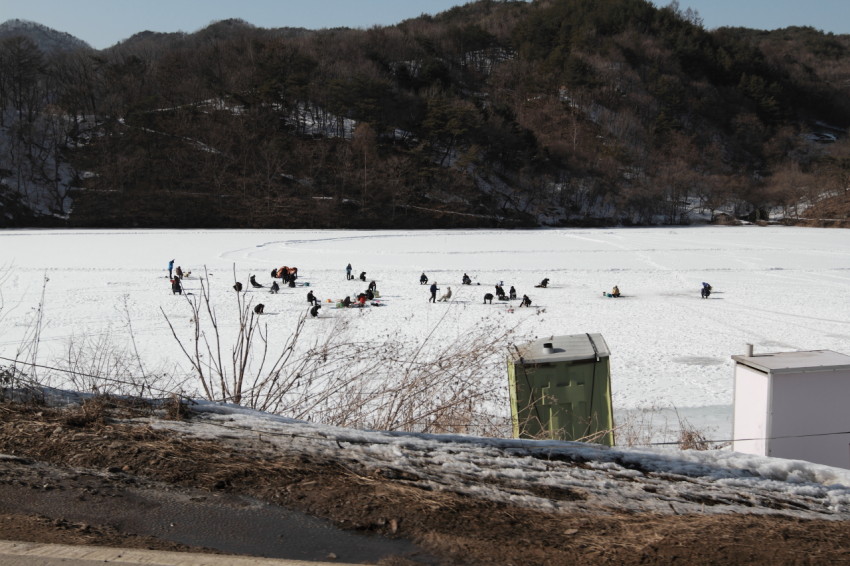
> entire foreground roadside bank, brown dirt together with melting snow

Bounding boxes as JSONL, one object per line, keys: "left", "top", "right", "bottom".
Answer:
{"left": 0, "top": 398, "right": 850, "bottom": 566}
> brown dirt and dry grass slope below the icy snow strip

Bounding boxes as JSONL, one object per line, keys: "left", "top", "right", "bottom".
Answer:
{"left": 0, "top": 403, "right": 850, "bottom": 565}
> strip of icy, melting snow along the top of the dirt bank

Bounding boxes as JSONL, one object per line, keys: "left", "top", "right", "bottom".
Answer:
{"left": 142, "top": 403, "right": 850, "bottom": 520}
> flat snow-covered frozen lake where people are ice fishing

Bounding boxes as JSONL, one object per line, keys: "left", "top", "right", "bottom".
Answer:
{"left": 0, "top": 226, "right": 850, "bottom": 440}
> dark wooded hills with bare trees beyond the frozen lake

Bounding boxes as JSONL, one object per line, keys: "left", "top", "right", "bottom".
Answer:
{"left": 0, "top": 0, "right": 850, "bottom": 228}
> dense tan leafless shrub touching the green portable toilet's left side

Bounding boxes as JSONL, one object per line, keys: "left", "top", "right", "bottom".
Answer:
{"left": 321, "top": 323, "right": 514, "bottom": 436}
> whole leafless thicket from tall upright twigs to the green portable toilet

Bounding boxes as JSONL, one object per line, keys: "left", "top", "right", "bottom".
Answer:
{"left": 163, "top": 273, "right": 514, "bottom": 436}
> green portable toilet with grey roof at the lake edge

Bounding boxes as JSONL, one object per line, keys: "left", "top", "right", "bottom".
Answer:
{"left": 508, "top": 334, "right": 614, "bottom": 446}
